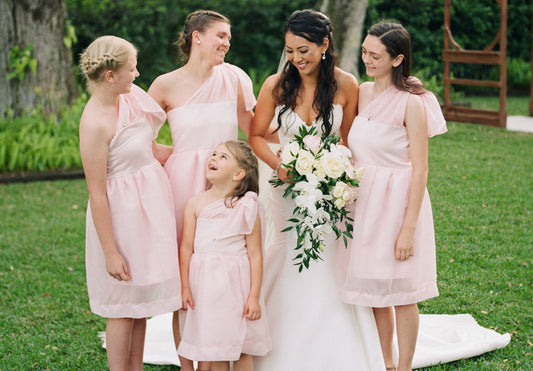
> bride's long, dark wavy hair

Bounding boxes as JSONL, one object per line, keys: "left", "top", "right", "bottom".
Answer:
{"left": 273, "top": 9, "right": 337, "bottom": 135}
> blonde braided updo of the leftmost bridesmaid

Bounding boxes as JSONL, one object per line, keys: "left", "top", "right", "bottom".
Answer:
{"left": 80, "top": 36, "right": 137, "bottom": 82}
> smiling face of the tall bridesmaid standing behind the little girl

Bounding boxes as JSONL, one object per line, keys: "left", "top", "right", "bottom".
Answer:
{"left": 193, "top": 22, "right": 231, "bottom": 65}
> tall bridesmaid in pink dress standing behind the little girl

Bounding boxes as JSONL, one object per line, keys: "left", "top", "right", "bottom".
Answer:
{"left": 148, "top": 10, "right": 256, "bottom": 371}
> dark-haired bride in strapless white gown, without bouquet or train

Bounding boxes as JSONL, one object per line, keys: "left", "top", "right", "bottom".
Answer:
{"left": 249, "top": 10, "right": 385, "bottom": 371}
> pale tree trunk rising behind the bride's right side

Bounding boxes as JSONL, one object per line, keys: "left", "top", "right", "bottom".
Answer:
{"left": 320, "top": 0, "right": 368, "bottom": 77}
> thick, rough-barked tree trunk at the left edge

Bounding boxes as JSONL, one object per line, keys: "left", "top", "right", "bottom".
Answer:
{"left": 0, "top": 0, "right": 76, "bottom": 117}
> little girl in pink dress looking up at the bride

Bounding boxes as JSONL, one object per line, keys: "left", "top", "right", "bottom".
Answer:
{"left": 178, "top": 141, "right": 271, "bottom": 370}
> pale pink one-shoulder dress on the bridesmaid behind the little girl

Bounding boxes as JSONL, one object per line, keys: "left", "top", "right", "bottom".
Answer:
{"left": 165, "top": 63, "right": 256, "bottom": 241}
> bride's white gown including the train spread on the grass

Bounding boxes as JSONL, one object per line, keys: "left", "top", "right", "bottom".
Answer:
{"left": 102, "top": 105, "right": 510, "bottom": 371}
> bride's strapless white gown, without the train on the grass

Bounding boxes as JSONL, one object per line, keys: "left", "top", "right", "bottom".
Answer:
{"left": 255, "top": 105, "right": 385, "bottom": 371}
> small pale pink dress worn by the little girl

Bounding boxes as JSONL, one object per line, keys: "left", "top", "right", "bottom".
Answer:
{"left": 178, "top": 192, "right": 272, "bottom": 361}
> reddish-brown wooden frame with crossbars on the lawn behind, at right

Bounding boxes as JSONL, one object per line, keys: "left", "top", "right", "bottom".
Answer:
{"left": 442, "top": 0, "right": 508, "bottom": 127}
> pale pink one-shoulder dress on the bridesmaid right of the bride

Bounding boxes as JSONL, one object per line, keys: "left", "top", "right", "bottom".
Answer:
{"left": 339, "top": 80, "right": 447, "bottom": 307}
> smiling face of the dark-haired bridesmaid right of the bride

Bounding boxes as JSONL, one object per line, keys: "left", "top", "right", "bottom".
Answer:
{"left": 361, "top": 35, "right": 403, "bottom": 79}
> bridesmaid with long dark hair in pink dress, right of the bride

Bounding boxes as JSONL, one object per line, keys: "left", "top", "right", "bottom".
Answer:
{"left": 339, "top": 22, "right": 446, "bottom": 371}
